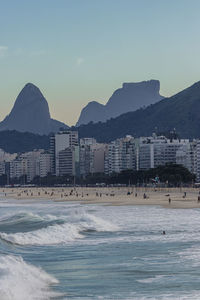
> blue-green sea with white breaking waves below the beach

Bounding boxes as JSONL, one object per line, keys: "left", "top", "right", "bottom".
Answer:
{"left": 0, "top": 199, "right": 200, "bottom": 300}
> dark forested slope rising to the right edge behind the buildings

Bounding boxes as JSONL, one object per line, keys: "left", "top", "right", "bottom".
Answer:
{"left": 78, "top": 81, "right": 200, "bottom": 142}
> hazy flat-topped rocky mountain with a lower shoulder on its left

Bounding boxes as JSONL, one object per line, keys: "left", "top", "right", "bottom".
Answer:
{"left": 76, "top": 80, "right": 163, "bottom": 126}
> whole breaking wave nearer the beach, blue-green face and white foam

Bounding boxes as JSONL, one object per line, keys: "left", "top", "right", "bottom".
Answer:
{"left": 0, "top": 213, "right": 117, "bottom": 246}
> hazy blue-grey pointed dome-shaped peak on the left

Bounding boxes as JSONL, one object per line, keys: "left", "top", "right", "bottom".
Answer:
{"left": 0, "top": 83, "right": 68, "bottom": 134}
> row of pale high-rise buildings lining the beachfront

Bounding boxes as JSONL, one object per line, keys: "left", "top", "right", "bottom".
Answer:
{"left": 0, "top": 131, "right": 200, "bottom": 182}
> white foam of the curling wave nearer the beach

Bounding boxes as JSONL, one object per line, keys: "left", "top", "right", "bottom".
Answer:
{"left": 0, "top": 214, "right": 118, "bottom": 246}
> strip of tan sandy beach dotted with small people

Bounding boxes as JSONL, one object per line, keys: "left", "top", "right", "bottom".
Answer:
{"left": 0, "top": 187, "right": 200, "bottom": 208}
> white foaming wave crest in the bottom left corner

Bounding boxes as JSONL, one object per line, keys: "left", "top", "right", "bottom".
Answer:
{"left": 0, "top": 255, "right": 61, "bottom": 300}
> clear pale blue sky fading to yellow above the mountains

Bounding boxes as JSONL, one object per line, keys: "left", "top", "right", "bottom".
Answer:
{"left": 0, "top": 0, "right": 200, "bottom": 125}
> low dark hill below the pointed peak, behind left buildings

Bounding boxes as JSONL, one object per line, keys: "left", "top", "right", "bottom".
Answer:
{"left": 0, "top": 130, "right": 49, "bottom": 153}
